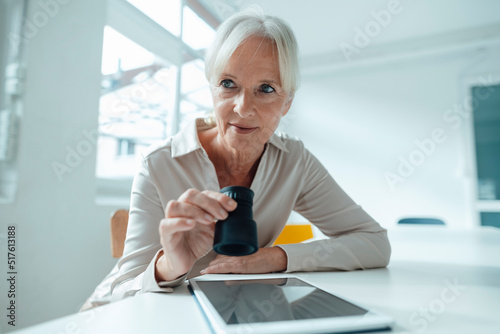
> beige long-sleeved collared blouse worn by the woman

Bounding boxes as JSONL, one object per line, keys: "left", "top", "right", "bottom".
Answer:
{"left": 84, "top": 119, "right": 391, "bottom": 305}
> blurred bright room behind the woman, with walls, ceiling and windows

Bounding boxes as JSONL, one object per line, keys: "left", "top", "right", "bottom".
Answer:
{"left": 0, "top": 0, "right": 500, "bottom": 331}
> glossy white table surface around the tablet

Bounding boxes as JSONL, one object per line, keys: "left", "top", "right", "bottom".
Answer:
{"left": 10, "top": 226, "right": 500, "bottom": 334}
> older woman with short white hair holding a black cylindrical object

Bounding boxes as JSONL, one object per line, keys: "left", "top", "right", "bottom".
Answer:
{"left": 82, "top": 11, "right": 390, "bottom": 306}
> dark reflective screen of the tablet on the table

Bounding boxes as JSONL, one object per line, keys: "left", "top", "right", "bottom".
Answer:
{"left": 197, "top": 278, "right": 368, "bottom": 324}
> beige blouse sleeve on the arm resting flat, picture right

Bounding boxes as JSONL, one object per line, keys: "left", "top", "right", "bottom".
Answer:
{"left": 279, "top": 149, "right": 391, "bottom": 272}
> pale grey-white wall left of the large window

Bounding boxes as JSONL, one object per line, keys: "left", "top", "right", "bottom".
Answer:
{"left": 0, "top": 0, "right": 119, "bottom": 331}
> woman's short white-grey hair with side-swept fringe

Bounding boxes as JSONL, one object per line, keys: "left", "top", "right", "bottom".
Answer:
{"left": 205, "top": 7, "right": 300, "bottom": 97}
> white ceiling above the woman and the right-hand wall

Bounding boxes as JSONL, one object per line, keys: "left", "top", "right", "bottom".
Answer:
{"left": 199, "top": 0, "right": 500, "bottom": 57}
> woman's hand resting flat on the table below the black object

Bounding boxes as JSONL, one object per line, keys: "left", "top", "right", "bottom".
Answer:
{"left": 200, "top": 247, "right": 287, "bottom": 275}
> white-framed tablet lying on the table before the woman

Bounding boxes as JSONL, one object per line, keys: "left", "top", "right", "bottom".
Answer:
{"left": 189, "top": 275, "right": 394, "bottom": 334}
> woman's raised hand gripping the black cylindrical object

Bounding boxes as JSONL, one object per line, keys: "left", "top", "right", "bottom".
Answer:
{"left": 156, "top": 189, "right": 237, "bottom": 281}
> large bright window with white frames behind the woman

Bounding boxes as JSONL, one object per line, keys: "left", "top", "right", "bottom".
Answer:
{"left": 96, "top": 0, "right": 215, "bottom": 183}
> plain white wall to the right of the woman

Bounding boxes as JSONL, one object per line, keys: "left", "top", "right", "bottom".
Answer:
{"left": 283, "top": 46, "right": 500, "bottom": 227}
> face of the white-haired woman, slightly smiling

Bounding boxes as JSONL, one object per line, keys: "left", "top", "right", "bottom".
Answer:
{"left": 211, "top": 37, "right": 292, "bottom": 155}
